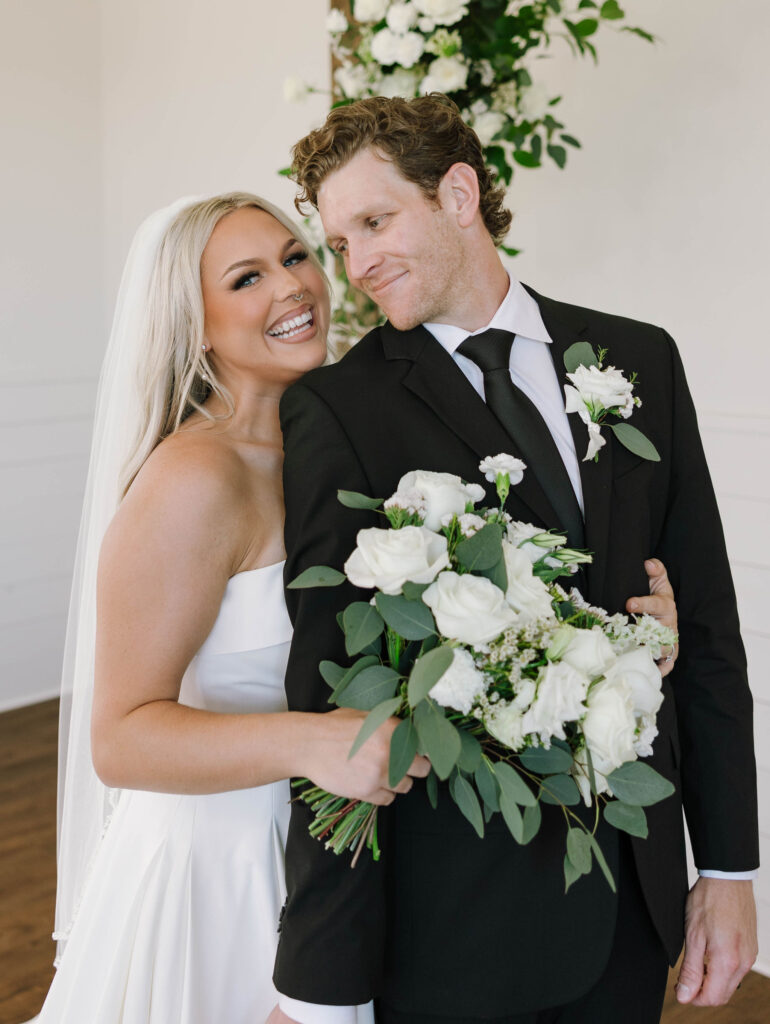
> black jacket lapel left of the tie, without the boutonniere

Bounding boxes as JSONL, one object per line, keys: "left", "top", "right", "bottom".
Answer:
{"left": 380, "top": 323, "right": 558, "bottom": 526}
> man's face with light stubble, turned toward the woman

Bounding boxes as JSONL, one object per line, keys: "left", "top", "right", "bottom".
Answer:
{"left": 318, "top": 148, "right": 463, "bottom": 331}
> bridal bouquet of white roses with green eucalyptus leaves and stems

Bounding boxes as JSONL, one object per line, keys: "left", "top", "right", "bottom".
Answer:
{"left": 290, "top": 455, "right": 676, "bottom": 889}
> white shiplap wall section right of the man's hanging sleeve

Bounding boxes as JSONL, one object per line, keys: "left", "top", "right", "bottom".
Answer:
{"left": 699, "top": 414, "right": 770, "bottom": 975}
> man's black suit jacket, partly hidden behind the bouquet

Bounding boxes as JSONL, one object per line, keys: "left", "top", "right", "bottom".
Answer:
{"left": 274, "top": 293, "right": 759, "bottom": 1017}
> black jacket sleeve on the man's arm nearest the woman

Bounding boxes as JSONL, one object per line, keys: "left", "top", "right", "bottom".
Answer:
{"left": 273, "top": 383, "right": 385, "bottom": 1006}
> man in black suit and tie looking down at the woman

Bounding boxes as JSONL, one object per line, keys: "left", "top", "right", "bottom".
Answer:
{"left": 274, "top": 96, "right": 758, "bottom": 1024}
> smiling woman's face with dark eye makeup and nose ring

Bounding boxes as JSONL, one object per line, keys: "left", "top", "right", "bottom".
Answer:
{"left": 201, "top": 207, "right": 329, "bottom": 387}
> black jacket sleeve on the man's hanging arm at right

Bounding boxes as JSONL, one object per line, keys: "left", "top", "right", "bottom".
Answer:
{"left": 656, "top": 335, "right": 759, "bottom": 871}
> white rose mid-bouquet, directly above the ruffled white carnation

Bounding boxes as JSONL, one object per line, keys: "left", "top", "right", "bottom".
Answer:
{"left": 423, "top": 571, "right": 516, "bottom": 646}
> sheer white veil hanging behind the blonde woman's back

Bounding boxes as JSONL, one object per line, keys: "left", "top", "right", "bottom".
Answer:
{"left": 53, "top": 197, "right": 200, "bottom": 956}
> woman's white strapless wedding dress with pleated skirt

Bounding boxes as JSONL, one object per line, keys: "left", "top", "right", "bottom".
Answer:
{"left": 36, "top": 563, "right": 371, "bottom": 1024}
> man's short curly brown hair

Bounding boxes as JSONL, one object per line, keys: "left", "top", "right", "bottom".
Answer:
{"left": 291, "top": 92, "right": 511, "bottom": 245}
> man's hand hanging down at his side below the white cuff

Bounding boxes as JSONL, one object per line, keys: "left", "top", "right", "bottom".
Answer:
{"left": 677, "top": 878, "right": 758, "bottom": 1007}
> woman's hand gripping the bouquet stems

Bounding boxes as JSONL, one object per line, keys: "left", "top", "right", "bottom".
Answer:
{"left": 304, "top": 708, "right": 430, "bottom": 805}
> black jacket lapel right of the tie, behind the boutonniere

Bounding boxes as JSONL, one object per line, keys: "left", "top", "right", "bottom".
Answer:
{"left": 524, "top": 286, "right": 612, "bottom": 603}
